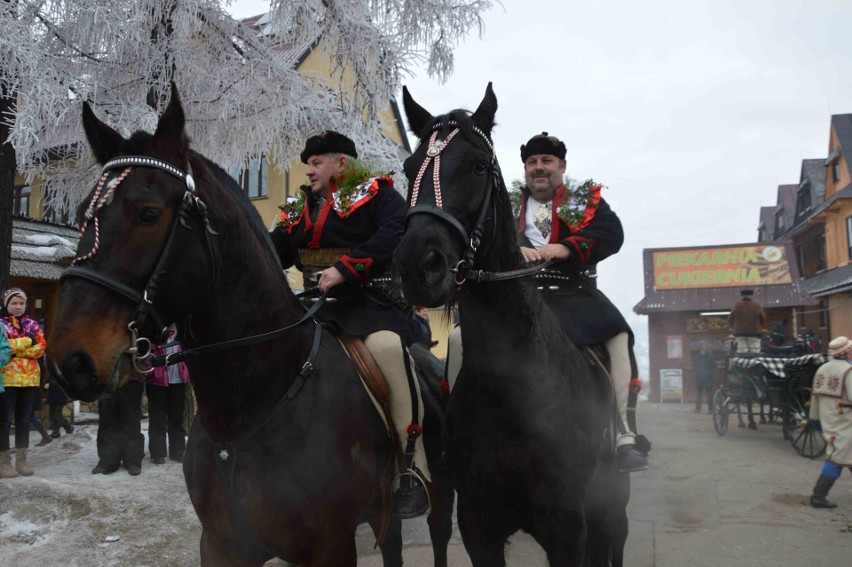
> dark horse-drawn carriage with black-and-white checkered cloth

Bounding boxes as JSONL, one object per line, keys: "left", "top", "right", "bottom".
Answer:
{"left": 713, "top": 346, "right": 828, "bottom": 459}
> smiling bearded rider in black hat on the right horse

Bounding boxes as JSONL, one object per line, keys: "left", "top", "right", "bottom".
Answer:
{"left": 447, "top": 132, "right": 648, "bottom": 472}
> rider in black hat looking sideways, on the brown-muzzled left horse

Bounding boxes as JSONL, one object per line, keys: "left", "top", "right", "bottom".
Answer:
{"left": 271, "top": 130, "right": 429, "bottom": 518}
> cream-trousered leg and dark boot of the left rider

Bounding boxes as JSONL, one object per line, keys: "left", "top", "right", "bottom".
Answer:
{"left": 364, "top": 331, "right": 429, "bottom": 518}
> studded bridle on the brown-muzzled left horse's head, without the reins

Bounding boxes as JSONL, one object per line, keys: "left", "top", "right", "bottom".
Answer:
{"left": 59, "top": 156, "right": 218, "bottom": 372}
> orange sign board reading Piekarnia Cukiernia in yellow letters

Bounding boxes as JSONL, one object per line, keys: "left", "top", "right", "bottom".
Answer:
{"left": 654, "top": 244, "right": 792, "bottom": 291}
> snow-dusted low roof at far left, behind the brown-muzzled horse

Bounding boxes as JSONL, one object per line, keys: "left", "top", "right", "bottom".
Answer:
{"left": 9, "top": 217, "right": 80, "bottom": 281}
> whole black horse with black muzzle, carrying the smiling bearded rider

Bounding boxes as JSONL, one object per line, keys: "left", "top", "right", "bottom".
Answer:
{"left": 394, "top": 84, "right": 629, "bottom": 567}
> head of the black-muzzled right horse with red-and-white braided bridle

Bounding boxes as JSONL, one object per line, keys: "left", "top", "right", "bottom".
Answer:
{"left": 393, "top": 83, "right": 520, "bottom": 307}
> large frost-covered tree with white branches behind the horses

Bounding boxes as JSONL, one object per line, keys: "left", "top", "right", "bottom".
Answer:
{"left": 0, "top": 0, "right": 492, "bottom": 279}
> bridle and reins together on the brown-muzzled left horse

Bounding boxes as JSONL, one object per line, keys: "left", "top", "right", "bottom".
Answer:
{"left": 59, "top": 156, "right": 326, "bottom": 382}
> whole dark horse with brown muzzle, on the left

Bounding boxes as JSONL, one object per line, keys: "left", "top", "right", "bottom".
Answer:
{"left": 48, "top": 84, "right": 452, "bottom": 567}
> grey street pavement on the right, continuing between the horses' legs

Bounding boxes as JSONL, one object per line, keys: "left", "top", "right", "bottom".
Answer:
{"left": 348, "top": 403, "right": 852, "bottom": 567}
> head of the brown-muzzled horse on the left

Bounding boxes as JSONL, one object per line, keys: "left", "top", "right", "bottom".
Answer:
{"left": 48, "top": 85, "right": 226, "bottom": 400}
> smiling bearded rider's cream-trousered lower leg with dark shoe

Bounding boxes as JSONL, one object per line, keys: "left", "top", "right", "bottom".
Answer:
{"left": 606, "top": 332, "right": 648, "bottom": 473}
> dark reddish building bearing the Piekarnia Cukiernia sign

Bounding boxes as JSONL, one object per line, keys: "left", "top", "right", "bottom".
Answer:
{"left": 633, "top": 242, "right": 819, "bottom": 401}
